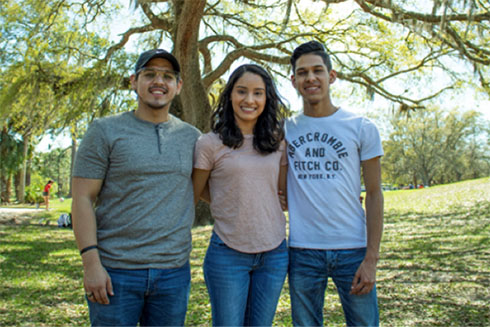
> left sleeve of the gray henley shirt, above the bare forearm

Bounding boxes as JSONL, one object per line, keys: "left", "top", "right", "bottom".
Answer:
{"left": 73, "top": 121, "right": 110, "bottom": 179}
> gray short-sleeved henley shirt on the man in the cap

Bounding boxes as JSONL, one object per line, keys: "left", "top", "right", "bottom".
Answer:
{"left": 73, "top": 112, "right": 200, "bottom": 269}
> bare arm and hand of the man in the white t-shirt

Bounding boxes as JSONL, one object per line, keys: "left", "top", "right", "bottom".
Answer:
{"left": 351, "top": 157, "right": 383, "bottom": 295}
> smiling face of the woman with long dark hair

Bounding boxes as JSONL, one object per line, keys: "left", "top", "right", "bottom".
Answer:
{"left": 231, "top": 72, "right": 267, "bottom": 134}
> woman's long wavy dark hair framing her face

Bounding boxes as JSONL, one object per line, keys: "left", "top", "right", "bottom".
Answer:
{"left": 211, "top": 64, "right": 286, "bottom": 154}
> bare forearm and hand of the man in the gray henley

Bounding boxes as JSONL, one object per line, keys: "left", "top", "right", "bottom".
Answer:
{"left": 71, "top": 177, "right": 114, "bottom": 304}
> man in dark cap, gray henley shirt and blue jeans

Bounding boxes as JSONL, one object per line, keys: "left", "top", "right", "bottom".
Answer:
{"left": 72, "top": 49, "right": 200, "bottom": 326}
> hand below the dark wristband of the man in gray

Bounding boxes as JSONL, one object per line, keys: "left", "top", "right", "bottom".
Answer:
{"left": 83, "top": 263, "right": 114, "bottom": 304}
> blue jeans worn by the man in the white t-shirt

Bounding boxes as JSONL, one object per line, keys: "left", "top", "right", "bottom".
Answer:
{"left": 289, "top": 248, "right": 379, "bottom": 326}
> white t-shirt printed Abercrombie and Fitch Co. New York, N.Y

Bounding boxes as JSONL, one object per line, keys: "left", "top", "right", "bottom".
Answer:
{"left": 285, "top": 109, "right": 383, "bottom": 250}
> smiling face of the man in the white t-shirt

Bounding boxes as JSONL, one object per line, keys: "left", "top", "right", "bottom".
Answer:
{"left": 291, "top": 54, "right": 337, "bottom": 105}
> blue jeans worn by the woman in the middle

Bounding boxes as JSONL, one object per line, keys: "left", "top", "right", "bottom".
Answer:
{"left": 203, "top": 232, "right": 288, "bottom": 326}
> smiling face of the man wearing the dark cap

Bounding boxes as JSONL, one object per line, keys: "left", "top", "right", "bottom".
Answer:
{"left": 131, "top": 58, "right": 182, "bottom": 111}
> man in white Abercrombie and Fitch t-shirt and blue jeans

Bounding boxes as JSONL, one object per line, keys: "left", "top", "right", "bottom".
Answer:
{"left": 285, "top": 41, "right": 383, "bottom": 326}
